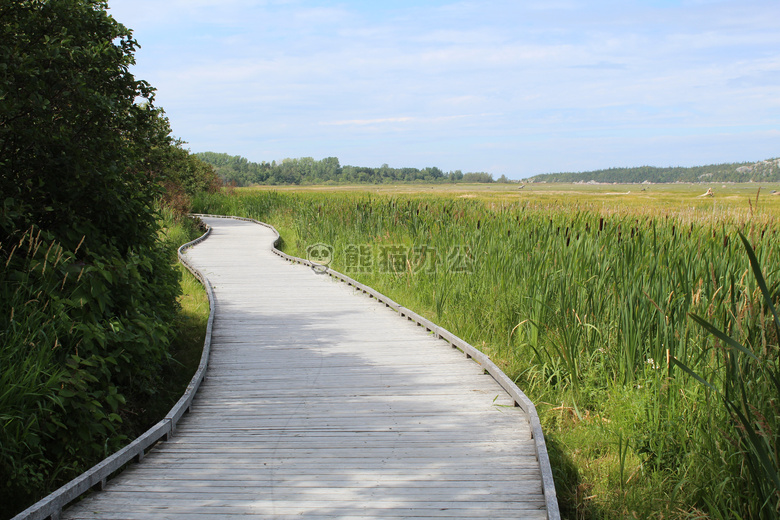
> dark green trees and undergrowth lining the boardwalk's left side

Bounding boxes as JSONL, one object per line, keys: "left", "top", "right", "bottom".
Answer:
{"left": 0, "top": 0, "right": 215, "bottom": 517}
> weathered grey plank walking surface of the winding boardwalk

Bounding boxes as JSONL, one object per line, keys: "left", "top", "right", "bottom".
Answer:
{"left": 62, "top": 219, "right": 547, "bottom": 520}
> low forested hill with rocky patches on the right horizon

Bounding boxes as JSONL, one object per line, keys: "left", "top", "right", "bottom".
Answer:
{"left": 526, "top": 159, "right": 780, "bottom": 183}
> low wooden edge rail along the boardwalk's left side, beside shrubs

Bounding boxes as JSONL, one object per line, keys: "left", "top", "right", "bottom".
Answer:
{"left": 12, "top": 218, "right": 218, "bottom": 520}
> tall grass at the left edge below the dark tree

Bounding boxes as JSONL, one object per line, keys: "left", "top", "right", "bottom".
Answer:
{"left": 0, "top": 229, "right": 72, "bottom": 507}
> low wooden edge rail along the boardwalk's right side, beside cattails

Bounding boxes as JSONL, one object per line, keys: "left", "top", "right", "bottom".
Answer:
{"left": 193, "top": 214, "right": 561, "bottom": 520}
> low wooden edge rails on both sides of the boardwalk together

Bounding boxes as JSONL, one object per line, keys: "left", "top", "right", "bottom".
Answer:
{"left": 12, "top": 214, "right": 560, "bottom": 520}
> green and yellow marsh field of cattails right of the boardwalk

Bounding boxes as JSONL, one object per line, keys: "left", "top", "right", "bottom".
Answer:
{"left": 194, "top": 184, "right": 780, "bottom": 518}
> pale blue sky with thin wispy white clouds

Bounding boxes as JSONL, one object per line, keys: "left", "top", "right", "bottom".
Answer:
{"left": 109, "top": 0, "right": 780, "bottom": 179}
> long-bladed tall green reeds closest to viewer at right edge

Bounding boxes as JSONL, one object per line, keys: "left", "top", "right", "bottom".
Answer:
{"left": 674, "top": 234, "right": 780, "bottom": 519}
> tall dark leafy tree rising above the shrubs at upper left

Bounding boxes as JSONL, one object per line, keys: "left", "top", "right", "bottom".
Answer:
{"left": 0, "top": 0, "right": 167, "bottom": 250}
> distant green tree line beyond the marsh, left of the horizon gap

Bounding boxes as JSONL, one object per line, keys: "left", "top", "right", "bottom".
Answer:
{"left": 195, "top": 152, "right": 500, "bottom": 186}
